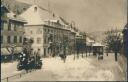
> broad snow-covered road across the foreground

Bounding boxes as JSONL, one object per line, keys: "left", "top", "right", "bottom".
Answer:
{"left": 10, "top": 55, "right": 124, "bottom": 81}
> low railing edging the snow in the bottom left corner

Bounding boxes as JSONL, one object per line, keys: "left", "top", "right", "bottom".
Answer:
{"left": 1, "top": 70, "right": 34, "bottom": 82}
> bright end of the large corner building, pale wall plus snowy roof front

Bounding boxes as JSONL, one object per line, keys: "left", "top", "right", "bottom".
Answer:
{"left": 20, "top": 5, "right": 43, "bottom": 56}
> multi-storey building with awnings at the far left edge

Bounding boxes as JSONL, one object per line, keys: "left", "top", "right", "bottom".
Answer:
{"left": 1, "top": 5, "right": 26, "bottom": 60}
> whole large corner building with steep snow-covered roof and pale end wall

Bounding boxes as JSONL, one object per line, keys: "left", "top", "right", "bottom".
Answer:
{"left": 20, "top": 5, "right": 75, "bottom": 56}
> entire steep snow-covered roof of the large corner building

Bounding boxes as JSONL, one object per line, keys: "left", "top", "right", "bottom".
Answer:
{"left": 20, "top": 5, "right": 60, "bottom": 25}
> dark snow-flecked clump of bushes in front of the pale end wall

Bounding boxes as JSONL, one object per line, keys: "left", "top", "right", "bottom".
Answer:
{"left": 17, "top": 49, "right": 42, "bottom": 71}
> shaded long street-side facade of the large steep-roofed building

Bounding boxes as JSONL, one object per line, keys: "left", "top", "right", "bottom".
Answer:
{"left": 43, "top": 20, "right": 73, "bottom": 56}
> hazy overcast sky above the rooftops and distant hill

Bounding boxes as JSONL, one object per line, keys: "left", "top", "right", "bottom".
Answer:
{"left": 18, "top": 0, "right": 127, "bottom": 32}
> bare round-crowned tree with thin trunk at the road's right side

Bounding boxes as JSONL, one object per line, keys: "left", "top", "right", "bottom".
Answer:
{"left": 103, "top": 29, "right": 122, "bottom": 61}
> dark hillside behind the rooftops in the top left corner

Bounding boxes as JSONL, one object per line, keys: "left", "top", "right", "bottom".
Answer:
{"left": 1, "top": 0, "right": 30, "bottom": 14}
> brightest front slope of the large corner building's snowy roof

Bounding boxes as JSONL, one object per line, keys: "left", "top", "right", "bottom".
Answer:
{"left": 20, "top": 5, "right": 43, "bottom": 25}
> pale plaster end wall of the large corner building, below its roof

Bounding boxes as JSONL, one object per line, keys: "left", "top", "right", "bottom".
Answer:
{"left": 25, "top": 25, "right": 44, "bottom": 56}
